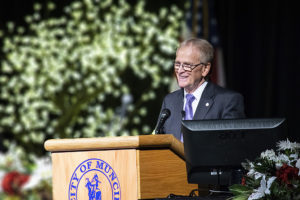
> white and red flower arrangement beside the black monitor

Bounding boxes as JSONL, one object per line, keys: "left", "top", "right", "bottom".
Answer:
{"left": 230, "top": 139, "right": 300, "bottom": 200}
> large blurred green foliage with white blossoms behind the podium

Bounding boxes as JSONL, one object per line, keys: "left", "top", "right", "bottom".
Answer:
{"left": 0, "top": 0, "right": 183, "bottom": 155}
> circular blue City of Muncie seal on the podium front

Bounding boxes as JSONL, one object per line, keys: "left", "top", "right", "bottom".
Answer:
{"left": 68, "top": 158, "right": 121, "bottom": 200}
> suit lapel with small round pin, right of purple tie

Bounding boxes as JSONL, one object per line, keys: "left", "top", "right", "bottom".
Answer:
{"left": 193, "top": 82, "right": 214, "bottom": 120}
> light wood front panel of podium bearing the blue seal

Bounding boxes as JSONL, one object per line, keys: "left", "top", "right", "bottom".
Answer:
{"left": 52, "top": 149, "right": 138, "bottom": 200}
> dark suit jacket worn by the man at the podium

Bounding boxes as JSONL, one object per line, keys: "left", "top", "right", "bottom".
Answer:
{"left": 158, "top": 82, "right": 245, "bottom": 140}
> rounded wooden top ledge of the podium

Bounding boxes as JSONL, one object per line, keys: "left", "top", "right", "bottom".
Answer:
{"left": 44, "top": 134, "right": 184, "bottom": 158}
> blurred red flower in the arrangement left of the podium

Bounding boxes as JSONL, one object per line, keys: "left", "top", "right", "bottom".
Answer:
{"left": 2, "top": 171, "right": 29, "bottom": 195}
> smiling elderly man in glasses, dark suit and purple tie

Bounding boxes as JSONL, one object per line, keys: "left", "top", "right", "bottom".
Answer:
{"left": 158, "top": 38, "right": 245, "bottom": 141}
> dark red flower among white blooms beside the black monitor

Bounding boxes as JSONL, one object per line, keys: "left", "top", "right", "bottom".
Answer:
{"left": 276, "top": 164, "right": 299, "bottom": 185}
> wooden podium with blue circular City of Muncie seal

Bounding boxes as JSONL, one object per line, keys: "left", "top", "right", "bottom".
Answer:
{"left": 45, "top": 135, "right": 197, "bottom": 200}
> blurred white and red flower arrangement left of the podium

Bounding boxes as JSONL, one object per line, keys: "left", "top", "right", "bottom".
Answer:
{"left": 0, "top": 145, "right": 52, "bottom": 200}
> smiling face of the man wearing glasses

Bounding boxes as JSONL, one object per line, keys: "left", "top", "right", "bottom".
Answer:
{"left": 175, "top": 46, "right": 210, "bottom": 93}
